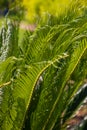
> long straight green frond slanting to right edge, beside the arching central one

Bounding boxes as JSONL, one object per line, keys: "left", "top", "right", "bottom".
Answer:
{"left": 31, "top": 41, "right": 87, "bottom": 130}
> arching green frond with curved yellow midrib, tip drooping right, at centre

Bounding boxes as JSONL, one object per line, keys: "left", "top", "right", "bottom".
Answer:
{"left": 1, "top": 53, "right": 66, "bottom": 130}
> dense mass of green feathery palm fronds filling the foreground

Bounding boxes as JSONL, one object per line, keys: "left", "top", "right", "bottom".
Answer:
{"left": 0, "top": 0, "right": 87, "bottom": 130}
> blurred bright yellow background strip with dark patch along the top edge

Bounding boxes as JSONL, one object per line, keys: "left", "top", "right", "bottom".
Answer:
{"left": 0, "top": 0, "right": 87, "bottom": 23}
